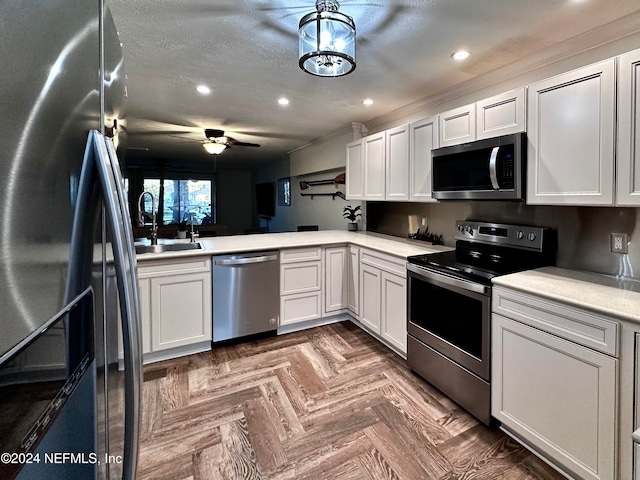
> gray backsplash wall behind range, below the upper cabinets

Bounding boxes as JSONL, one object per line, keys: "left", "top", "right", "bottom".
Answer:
{"left": 367, "top": 202, "right": 640, "bottom": 280}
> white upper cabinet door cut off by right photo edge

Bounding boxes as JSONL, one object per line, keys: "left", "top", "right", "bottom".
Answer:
{"left": 616, "top": 50, "right": 640, "bottom": 206}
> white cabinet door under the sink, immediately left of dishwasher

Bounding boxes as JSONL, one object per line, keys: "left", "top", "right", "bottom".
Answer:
{"left": 151, "top": 273, "right": 212, "bottom": 352}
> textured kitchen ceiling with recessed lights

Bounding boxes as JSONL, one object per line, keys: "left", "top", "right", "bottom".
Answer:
{"left": 109, "top": 0, "right": 640, "bottom": 169}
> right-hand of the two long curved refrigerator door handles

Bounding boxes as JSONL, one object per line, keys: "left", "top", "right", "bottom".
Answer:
{"left": 90, "top": 131, "right": 142, "bottom": 480}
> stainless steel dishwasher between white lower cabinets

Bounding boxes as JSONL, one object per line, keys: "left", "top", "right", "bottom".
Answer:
{"left": 213, "top": 251, "right": 280, "bottom": 342}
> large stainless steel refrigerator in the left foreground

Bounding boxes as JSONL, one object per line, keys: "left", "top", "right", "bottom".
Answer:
{"left": 0, "top": 0, "right": 142, "bottom": 479}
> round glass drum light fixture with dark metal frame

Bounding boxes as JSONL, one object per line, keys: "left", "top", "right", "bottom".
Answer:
{"left": 298, "top": 0, "right": 356, "bottom": 77}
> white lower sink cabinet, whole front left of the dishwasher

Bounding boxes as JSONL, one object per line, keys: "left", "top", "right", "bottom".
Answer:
{"left": 138, "top": 257, "right": 212, "bottom": 362}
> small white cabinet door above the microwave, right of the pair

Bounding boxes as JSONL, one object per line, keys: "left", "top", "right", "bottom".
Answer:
{"left": 476, "top": 87, "right": 527, "bottom": 140}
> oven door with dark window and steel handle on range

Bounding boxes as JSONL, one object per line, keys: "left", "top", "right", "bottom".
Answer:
{"left": 407, "top": 264, "right": 491, "bottom": 382}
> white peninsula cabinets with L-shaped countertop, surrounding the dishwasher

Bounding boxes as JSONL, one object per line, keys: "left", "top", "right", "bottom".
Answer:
{"left": 131, "top": 230, "right": 451, "bottom": 363}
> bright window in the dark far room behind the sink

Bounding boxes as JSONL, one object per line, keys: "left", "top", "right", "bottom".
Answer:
{"left": 138, "top": 178, "right": 215, "bottom": 225}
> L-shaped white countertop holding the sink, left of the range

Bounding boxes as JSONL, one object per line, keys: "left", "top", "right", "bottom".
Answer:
{"left": 137, "top": 230, "right": 453, "bottom": 262}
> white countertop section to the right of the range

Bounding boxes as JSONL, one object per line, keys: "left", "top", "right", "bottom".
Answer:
{"left": 493, "top": 267, "right": 640, "bottom": 323}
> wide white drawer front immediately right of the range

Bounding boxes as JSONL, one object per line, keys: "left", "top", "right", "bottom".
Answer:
{"left": 492, "top": 287, "right": 618, "bottom": 357}
